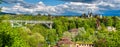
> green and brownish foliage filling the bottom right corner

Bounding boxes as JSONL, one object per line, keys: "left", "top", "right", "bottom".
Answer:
{"left": 95, "top": 32, "right": 120, "bottom": 47}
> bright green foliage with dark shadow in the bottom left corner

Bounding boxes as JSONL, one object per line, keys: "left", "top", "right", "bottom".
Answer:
{"left": 0, "top": 23, "right": 29, "bottom": 47}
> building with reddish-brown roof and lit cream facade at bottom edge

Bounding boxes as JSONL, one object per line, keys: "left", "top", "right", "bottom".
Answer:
{"left": 53, "top": 37, "right": 94, "bottom": 47}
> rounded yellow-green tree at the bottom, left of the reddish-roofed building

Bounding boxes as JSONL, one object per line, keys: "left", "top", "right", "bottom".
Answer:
{"left": 28, "top": 33, "right": 45, "bottom": 47}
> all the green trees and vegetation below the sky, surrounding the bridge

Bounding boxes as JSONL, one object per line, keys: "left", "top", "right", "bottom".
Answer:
{"left": 0, "top": 14, "right": 120, "bottom": 47}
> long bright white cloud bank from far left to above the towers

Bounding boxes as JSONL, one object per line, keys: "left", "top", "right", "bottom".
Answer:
{"left": 2, "top": 2, "right": 97, "bottom": 15}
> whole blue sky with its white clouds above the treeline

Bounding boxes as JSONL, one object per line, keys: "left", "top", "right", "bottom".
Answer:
{"left": 0, "top": 0, "right": 120, "bottom": 16}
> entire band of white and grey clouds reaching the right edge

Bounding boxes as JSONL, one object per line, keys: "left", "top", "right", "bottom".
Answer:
{"left": 2, "top": 0, "right": 120, "bottom": 15}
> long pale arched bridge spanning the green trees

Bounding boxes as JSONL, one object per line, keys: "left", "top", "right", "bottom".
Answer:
{"left": 4, "top": 20, "right": 53, "bottom": 29}
